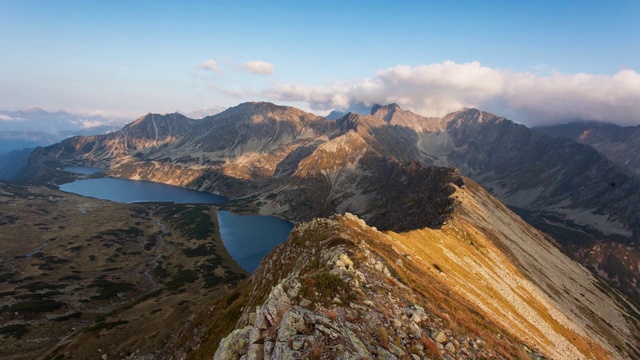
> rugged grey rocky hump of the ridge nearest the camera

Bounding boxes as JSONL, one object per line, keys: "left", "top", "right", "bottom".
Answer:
{"left": 214, "top": 214, "right": 541, "bottom": 359}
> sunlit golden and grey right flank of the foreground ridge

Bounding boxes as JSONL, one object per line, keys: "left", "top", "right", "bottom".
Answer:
{"left": 390, "top": 179, "right": 639, "bottom": 358}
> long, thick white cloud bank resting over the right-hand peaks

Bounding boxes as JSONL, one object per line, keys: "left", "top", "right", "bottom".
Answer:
{"left": 262, "top": 61, "right": 640, "bottom": 126}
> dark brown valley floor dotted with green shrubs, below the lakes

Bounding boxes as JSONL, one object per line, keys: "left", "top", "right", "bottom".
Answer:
{"left": 0, "top": 183, "right": 246, "bottom": 359}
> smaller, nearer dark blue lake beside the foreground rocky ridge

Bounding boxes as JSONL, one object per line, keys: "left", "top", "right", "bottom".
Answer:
{"left": 218, "top": 211, "right": 293, "bottom": 272}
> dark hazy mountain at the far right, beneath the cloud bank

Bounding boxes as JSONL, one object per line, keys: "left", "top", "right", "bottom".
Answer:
{"left": 536, "top": 121, "right": 640, "bottom": 177}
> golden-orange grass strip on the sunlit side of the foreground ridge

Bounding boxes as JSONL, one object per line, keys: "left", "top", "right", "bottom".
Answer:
{"left": 384, "top": 210, "right": 607, "bottom": 359}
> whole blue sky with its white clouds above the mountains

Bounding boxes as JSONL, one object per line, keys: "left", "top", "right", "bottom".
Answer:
{"left": 0, "top": 0, "right": 640, "bottom": 125}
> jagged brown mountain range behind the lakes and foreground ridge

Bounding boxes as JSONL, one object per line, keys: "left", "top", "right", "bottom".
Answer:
{"left": 22, "top": 103, "right": 640, "bottom": 297}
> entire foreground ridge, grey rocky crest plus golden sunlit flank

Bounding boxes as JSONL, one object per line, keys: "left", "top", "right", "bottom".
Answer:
{"left": 214, "top": 183, "right": 640, "bottom": 359}
